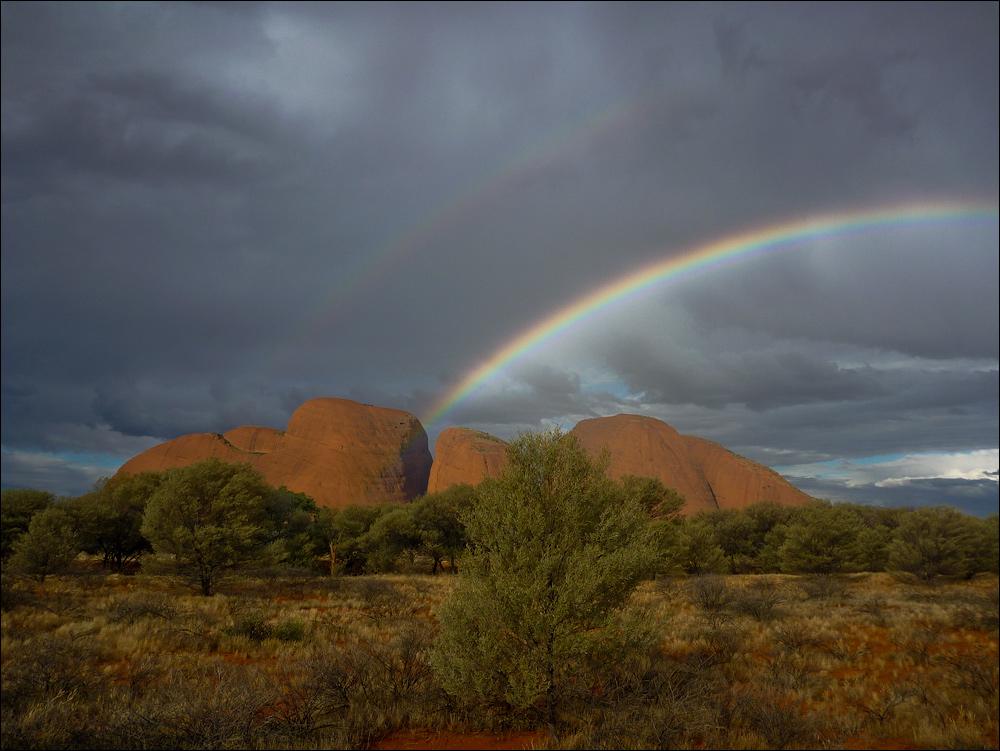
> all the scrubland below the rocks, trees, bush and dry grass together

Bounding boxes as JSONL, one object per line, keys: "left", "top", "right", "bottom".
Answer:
{"left": 0, "top": 432, "right": 1000, "bottom": 749}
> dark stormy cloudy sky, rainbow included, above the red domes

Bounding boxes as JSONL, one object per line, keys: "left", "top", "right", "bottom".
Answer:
{"left": 0, "top": 2, "right": 1000, "bottom": 516}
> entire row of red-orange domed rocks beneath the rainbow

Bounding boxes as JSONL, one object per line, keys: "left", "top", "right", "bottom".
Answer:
{"left": 118, "top": 399, "right": 810, "bottom": 515}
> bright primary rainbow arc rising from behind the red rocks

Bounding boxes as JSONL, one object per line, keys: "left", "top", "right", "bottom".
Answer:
{"left": 423, "top": 202, "right": 998, "bottom": 426}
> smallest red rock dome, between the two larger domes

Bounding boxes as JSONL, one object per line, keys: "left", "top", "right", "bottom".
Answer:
{"left": 427, "top": 428, "right": 507, "bottom": 493}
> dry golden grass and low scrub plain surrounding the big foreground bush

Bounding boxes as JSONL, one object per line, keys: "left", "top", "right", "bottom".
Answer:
{"left": 0, "top": 572, "right": 998, "bottom": 749}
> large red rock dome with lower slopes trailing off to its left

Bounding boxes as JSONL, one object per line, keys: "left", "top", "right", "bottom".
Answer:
{"left": 118, "top": 399, "right": 431, "bottom": 509}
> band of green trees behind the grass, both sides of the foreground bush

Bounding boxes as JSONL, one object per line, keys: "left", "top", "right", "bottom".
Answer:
{"left": 0, "top": 460, "right": 1000, "bottom": 594}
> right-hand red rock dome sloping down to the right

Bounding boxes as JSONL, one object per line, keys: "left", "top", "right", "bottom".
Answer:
{"left": 570, "top": 415, "right": 811, "bottom": 515}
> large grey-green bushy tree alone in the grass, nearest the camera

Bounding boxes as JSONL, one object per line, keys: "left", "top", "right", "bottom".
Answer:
{"left": 431, "top": 430, "right": 657, "bottom": 732}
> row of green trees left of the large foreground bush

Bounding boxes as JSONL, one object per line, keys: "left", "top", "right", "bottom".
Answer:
{"left": 0, "top": 459, "right": 475, "bottom": 595}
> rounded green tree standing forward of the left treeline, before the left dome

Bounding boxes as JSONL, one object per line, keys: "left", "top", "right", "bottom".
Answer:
{"left": 141, "top": 459, "right": 272, "bottom": 596}
